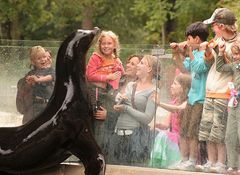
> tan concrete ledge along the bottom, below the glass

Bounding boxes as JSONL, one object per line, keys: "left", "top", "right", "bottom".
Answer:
{"left": 29, "top": 164, "right": 217, "bottom": 175}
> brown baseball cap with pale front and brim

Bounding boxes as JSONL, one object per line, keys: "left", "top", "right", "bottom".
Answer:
{"left": 203, "top": 8, "right": 237, "bottom": 25}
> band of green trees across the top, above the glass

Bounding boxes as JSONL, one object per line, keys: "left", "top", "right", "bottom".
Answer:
{"left": 0, "top": 0, "right": 240, "bottom": 45}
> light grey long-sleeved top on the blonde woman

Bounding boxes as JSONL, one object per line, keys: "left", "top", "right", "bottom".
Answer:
{"left": 116, "top": 82, "right": 156, "bottom": 129}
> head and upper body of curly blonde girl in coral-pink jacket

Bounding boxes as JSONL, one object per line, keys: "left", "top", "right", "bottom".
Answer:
{"left": 86, "top": 31, "right": 124, "bottom": 89}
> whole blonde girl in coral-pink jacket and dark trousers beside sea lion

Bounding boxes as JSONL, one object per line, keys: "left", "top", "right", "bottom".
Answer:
{"left": 86, "top": 31, "right": 124, "bottom": 154}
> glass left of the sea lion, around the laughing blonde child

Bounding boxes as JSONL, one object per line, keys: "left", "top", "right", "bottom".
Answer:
{"left": 0, "top": 40, "right": 59, "bottom": 127}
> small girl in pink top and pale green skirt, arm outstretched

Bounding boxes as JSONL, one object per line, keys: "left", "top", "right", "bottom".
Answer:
{"left": 150, "top": 74, "right": 191, "bottom": 168}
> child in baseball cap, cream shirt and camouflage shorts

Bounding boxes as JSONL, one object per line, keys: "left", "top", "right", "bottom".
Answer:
{"left": 196, "top": 8, "right": 240, "bottom": 174}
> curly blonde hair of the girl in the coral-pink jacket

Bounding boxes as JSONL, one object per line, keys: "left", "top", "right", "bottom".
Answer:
{"left": 96, "top": 31, "right": 120, "bottom": 58}
